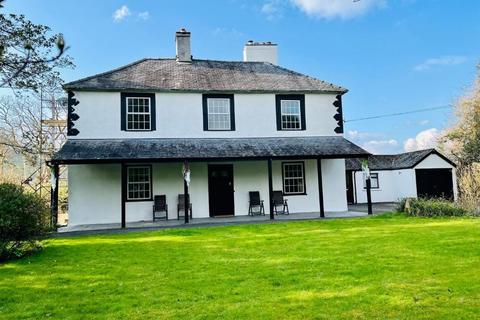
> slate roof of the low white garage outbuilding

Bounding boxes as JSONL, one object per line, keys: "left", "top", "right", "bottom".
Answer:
{"left": 345, "top": 149, "right": 455, "bottom": 170}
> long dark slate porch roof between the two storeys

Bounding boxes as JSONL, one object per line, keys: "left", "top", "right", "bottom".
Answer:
{"left": 52, "top": 136, "right": 370, "bottom": 164}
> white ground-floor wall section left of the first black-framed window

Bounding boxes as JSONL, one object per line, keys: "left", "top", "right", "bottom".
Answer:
{"left": 68, "top": 164, "right": 122, "bottom": 225}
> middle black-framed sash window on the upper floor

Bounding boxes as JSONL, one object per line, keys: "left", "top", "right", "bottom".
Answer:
{"left": 203, "top": 94, "right": 235, "bottom": 131}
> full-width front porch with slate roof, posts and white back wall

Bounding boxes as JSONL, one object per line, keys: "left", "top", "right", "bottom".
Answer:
{"left": 52, "top": 136, "right": 368, "bottom": 230}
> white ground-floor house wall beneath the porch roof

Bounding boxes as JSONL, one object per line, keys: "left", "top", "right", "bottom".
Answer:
{"left": 69, "top": 159, "right": 347, "bottom": 226}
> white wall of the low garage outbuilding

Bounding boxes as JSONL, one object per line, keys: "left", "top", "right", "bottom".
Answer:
{"left": 355, "top": 154, "right": 458, "bottom": 203}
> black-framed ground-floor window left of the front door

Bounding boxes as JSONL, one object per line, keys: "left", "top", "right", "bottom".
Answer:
{"left": 127, "top": 165, "right": 152, "bottom": 201}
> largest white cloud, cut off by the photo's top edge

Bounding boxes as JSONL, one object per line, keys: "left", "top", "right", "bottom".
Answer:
{"left": 290, "top": 0, "right": 386, "bottom": 19}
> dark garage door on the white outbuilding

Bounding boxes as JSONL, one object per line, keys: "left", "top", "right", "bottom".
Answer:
{"left": 415, "top": 169, "right": 453, "bottom": 199}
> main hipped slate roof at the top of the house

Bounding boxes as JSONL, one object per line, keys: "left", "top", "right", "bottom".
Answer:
{"left": 64, "top": 59, "right": 347, "bottom": 94}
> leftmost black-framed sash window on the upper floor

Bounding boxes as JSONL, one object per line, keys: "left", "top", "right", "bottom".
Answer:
{"left": 121, "top": 93, "right": 155, "bottom": 131}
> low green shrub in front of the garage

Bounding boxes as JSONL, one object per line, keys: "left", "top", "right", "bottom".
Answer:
{"left": 405, "top": 199, "right": 470, "bottom": 217}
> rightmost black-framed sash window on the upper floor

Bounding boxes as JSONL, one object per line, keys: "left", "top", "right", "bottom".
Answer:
{"left": 276, "top": 95, "right": 306, "bottom": 131}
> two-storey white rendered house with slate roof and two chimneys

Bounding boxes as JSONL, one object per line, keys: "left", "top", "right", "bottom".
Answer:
{"left": 52, "top": 30, "right": 369, "bottom": 227}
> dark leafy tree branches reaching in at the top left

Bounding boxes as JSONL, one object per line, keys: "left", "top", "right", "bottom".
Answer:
{"left": 0, "top": 0, "right": 73, "bottom": 90}
